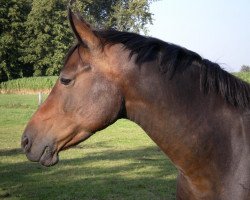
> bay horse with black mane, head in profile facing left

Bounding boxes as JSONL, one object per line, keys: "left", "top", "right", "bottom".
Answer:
{"left": 21, "top": 10, "right": 250, "bottom": 200}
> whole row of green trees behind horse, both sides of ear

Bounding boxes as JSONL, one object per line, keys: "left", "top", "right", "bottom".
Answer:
{"left": 0, "top": 0, "right": 155, "bottom": 82}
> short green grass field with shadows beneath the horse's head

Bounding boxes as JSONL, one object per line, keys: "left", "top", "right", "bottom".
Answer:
{"left": 0, "top": 94, "right": 177, "bottom": 200}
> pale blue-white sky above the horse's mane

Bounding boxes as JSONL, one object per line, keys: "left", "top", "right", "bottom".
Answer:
{"left": 148, "top": 0, "right": 250, "bottom": 72}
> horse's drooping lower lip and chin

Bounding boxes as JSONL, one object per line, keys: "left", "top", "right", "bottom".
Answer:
{"left": 39, "top": 146, "right": 59, "bottom": 167}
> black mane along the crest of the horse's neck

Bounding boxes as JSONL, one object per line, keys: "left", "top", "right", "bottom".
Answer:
{"left": 95, "top": 30, "right": 250, "bottom": 108}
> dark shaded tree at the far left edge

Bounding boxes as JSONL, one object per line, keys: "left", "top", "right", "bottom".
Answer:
{"left": 0, "top": 0, "right": 31, "bottom": 81}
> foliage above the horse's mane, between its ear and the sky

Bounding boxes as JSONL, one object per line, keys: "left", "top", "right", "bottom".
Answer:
{"left": 72, "top": 0, "right": 155, "bottom": 33}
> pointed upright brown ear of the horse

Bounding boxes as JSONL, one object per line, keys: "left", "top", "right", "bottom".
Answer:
{"left": 68, "top": 9, "right": 101, "bottom": 50}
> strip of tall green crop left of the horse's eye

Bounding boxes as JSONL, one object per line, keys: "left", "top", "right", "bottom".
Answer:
{"left": 0, "top": 76, "right": 57, "bottom": 93}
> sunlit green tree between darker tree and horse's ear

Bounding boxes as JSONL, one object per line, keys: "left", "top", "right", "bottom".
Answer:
{"left": 22, "top": 0, "right": 73, "bottom": 76}
